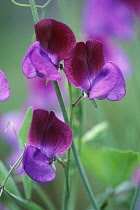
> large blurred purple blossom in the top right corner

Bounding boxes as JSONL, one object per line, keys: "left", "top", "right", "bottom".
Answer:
{"left": 82, "top": 0, "right": 140, "bottom": 39}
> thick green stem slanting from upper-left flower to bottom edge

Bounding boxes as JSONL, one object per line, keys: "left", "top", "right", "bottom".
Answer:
{"left": 53, "top": 81, "right": 99, "bottom": 210}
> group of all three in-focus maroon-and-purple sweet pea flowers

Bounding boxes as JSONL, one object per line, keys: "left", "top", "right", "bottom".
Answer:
{"left": 22, "top": 19, "right": 126, "bottom": 182}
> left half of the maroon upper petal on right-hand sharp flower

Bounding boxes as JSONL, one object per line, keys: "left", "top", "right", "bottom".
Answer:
{"left": 64, "top": 42, "right": 90, "bottom": 90}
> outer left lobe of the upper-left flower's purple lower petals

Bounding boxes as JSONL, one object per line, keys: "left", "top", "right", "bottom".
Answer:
{"left": 22, "top": 42, "right": 38, "bottom": 79}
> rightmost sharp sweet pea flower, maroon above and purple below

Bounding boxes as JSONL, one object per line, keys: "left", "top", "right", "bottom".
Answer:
{"left": 64, "top": 40, "right": 126, "bottom": 101}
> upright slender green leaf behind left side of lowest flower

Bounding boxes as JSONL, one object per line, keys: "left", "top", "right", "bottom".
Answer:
{"left": 18, "top": 107, "right": 33, "bottom": 148}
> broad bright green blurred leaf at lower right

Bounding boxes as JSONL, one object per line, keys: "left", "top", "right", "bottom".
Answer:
{"left": 81, "top": 145, "right": 140, "bottom": 187}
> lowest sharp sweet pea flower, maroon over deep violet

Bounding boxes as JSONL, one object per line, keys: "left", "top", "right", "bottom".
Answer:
{"left": 23, "top": 109, "right": 72, "bottom": 182}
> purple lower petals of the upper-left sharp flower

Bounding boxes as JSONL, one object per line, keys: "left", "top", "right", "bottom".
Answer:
{"left": 22, "top": 42, "right": 61, "bottom": 80}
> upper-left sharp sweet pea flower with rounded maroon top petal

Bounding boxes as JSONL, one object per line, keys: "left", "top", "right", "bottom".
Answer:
{"left": 22, "top": 19, "right": 76, "bottom": 80}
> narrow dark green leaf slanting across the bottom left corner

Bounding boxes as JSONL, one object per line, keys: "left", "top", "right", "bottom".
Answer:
{"left": 4, "top": 189, "right": 43, "bottom": 210}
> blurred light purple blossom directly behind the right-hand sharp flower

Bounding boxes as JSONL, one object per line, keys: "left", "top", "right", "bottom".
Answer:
{"left": 88, "top": 35, "right": 131, "bottom": 77}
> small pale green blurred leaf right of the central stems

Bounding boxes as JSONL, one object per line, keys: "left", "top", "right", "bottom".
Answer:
{"left": 81, "top": 122, "right": 108, "bottom": 142}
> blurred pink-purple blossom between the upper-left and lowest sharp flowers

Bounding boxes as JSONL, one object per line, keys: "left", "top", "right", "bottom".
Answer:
{"left": 26, "top": 77, "right": 66, "bottom": 111}
